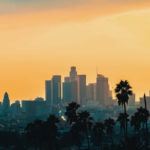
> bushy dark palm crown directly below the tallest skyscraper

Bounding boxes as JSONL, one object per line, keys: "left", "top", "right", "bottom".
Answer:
{"left": 65, "top": 102, "right": 80, "bottom": 125}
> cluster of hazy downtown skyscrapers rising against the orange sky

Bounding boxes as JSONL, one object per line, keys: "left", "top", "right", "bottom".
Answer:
{"left": 1, "top": 66, "right": 146, "bottom": 105}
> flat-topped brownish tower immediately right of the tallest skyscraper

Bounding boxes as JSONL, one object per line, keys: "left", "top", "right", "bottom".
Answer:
{"left": 77, "top": 75, "right": 86, "bottom": 105}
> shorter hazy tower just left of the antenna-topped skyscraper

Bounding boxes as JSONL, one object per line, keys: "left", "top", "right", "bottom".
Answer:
{"left": 86, "top": 83, "right": 96, "bottom": 101}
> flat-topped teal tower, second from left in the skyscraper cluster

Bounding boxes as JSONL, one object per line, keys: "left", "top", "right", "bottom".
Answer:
{"left": 51, "top": 75, "right": 61, "bottom": 105}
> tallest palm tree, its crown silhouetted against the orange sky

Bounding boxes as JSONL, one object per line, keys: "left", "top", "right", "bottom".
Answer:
{"left": 115, "top": 80, "right": 132, "bottom": 137}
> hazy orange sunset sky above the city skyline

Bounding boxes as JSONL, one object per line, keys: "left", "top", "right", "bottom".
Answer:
{"left": 0, "top": 0, "right": 150, "bottom": 100}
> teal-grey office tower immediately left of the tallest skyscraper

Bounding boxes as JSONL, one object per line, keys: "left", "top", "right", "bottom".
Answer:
{"left": 63, "top": 77, "right": 71, "bottom": 103}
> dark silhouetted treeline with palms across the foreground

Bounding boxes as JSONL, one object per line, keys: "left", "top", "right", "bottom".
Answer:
{"left": 0, "top": 81, "right": 150, "bottom": 150}
